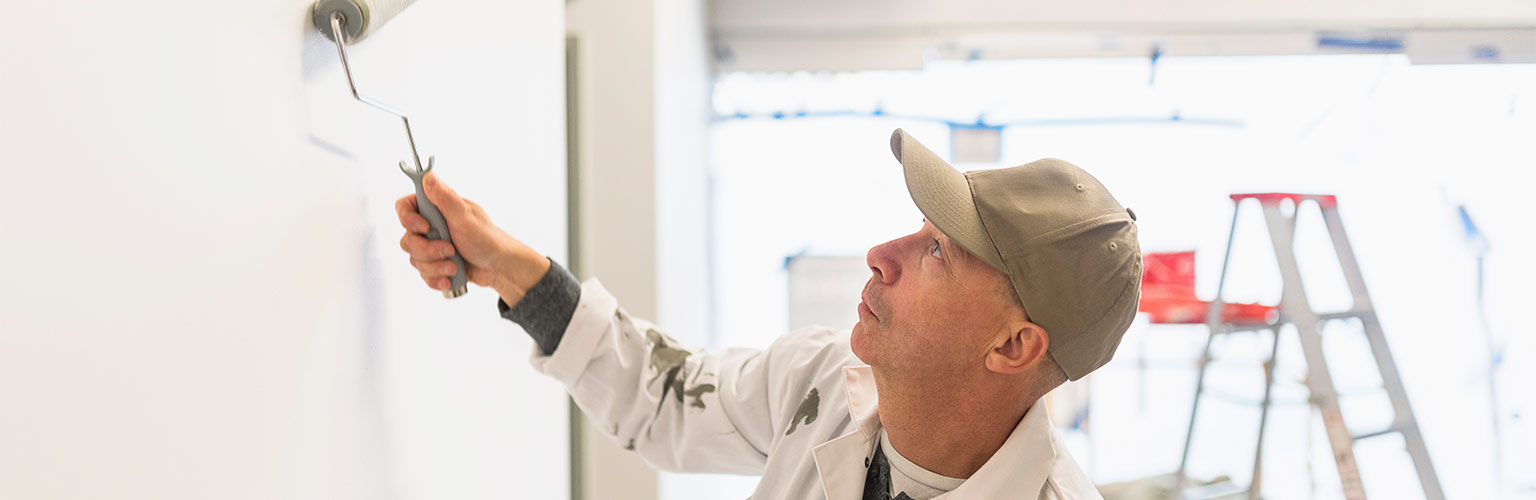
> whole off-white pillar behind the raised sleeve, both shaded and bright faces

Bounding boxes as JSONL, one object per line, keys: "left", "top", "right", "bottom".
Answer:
{"left": 567, "top": 0, "right": 710, "bottom": 498}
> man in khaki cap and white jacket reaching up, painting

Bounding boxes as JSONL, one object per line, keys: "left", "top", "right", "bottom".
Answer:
{"left": 396, "top": 129, "right": 1141, "bottom": 500}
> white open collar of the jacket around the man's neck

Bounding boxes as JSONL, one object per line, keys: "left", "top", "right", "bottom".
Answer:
{"left": 813, "top": 367, "right": 1057, "bottom": 500}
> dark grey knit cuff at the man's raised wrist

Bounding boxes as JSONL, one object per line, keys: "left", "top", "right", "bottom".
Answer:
{"left": 496, "top": 259, "right": 581, "bottom": 356}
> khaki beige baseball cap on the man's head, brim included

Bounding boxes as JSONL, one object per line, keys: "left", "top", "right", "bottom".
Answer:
{"left": 891, "top": 129, "right": 1141, "bottom": 380}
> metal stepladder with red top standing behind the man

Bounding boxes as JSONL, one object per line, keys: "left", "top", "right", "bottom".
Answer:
{"left": 1177, "top": 193, "right": 1445, "bottom": 500}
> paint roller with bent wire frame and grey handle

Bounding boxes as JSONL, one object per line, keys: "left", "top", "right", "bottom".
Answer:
{"left": 310, "top": 0, "right": 468, "bottom": 299}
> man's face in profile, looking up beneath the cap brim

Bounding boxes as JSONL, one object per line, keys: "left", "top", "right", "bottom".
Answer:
{"left": 851, "top": 219, "right": 1023, "bottom": 376}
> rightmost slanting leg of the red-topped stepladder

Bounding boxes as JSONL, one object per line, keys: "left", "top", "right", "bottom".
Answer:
{"left": 1322, "top": 207, "right": 1445, "bottom": 500}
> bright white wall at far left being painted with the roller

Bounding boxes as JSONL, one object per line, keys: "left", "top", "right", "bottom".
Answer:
{"left": 0, "top": 0, "right": 567, "bottom": 498}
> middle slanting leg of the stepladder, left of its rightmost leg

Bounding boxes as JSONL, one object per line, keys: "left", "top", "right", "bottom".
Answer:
{"left": 1264, "top": 204, "right": 1366, "bottom": 500}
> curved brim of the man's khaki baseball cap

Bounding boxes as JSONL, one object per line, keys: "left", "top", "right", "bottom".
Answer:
{"left": 891, "top": 129, "right": 1008, "bottom": 275}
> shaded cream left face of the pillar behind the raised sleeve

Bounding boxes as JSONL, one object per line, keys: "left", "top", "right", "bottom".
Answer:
{"left": 565, "top": 0, "right": 657, "bottom": 500}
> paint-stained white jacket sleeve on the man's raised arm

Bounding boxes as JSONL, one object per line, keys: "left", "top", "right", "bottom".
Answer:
{"left": 531, "top": 279, "right": 846, "bottom": 474}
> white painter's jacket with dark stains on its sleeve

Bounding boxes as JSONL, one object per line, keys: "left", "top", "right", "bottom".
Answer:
{"left": 531, "top": 279, "right": 1101, "bottom": 500}
